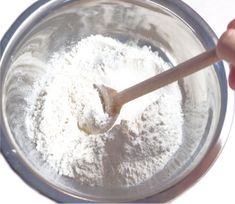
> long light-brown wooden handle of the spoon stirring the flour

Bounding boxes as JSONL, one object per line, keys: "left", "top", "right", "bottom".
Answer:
{"left": 114, "top": 48, "right": 219, "bottom": 107}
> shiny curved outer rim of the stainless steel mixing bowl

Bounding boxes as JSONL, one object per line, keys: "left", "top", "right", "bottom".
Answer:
{"left": 0, "top": 0, "right": 234, "bottom": 203}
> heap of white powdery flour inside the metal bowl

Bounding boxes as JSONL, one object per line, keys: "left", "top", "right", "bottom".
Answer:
{"left": 27, "top": 35, "right": 183, "bottom": 187}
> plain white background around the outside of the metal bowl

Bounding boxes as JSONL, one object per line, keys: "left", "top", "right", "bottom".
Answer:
{"left": 0, "top": 0, "right": 235, "bottom": 204}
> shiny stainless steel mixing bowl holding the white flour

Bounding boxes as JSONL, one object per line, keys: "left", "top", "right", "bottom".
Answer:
{"left": 1, "top": 0, "right": 234, "bottom": 202}
